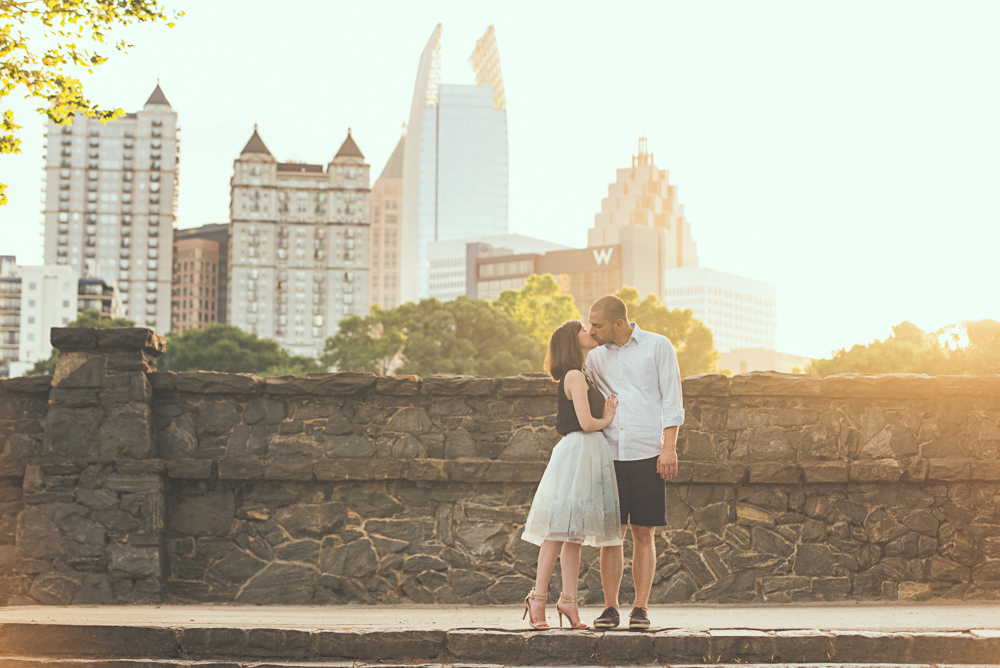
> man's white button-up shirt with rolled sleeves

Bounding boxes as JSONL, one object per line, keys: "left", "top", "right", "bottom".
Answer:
{"left": 586, "top": 322, "right": 684, "bottom": 461}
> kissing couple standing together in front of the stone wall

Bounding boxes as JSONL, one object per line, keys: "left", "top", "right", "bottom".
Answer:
{"left": 521, "top": 295, "right": 684, "bottom": 629}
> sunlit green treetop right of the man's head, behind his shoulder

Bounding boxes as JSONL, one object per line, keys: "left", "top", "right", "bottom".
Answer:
{"left": 615, "top": 286, "right": 719, "bottom": 377}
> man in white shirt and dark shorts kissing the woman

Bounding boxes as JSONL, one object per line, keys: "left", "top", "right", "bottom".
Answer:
{"left": 587, "top": 295, "right": 684, "bottom": 629}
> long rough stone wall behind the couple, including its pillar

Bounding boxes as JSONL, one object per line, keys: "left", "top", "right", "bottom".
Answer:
{"left": 0, "top": 329, "right": 1000, "bottom": 604}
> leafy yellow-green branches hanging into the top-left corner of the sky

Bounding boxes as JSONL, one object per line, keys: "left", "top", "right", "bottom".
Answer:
{"left": 0, "top": 0, "right": 184, "bottom": 206}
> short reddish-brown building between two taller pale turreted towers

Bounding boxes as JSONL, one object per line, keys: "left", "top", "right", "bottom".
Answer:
{"left": 171, "top": 238, "right": 220, "bottom": 333}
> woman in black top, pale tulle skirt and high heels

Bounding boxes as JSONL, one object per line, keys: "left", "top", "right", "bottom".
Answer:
{"left": 521, "top": 320, "right": 622, "bottom": 629}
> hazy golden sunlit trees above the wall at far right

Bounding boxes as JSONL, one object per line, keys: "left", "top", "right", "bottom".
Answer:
{"left": 807, "top": 320, "right": 1000, "bottom": 376}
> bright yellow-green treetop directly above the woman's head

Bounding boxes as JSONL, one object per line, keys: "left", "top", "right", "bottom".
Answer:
{"left": 493, "top": 274, "right": 580, "bottom": 346}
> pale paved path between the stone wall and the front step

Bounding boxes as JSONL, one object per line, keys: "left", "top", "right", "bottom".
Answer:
{"left": 0, "top": 603, "right": 1000, "bottom": 633}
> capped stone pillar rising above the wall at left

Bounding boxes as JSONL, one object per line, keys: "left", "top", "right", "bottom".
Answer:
{"left": 10, "top": 328, "right": 166, "bottom": 604}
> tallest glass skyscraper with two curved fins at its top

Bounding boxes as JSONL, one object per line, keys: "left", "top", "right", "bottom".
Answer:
{"left": 400, "top": 24, "right": 508, "bottom": 301}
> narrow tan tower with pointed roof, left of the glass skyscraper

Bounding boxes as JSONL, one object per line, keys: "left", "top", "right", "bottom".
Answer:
{"left": 368, "top": 134, "right": 406, "bottom": 308}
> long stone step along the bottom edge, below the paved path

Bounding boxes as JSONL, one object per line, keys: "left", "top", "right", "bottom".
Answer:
{"left": 0, "top": 623, "right": 1000, "bottom": 668}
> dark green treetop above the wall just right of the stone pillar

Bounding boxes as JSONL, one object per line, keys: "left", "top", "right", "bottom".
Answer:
{"left": 157, "top": 323, "right": 324, "bottom": 376}
